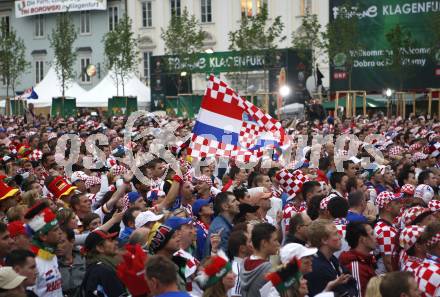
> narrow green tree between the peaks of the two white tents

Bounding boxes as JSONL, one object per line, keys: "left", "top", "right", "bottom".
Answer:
{"left": 49, "top": 12, "right": 77, "bottom": 98}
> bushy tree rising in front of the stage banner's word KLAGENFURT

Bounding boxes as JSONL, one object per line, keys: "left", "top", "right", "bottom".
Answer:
{"left": 229, "top": 6, "right": 286, "bottom": 88}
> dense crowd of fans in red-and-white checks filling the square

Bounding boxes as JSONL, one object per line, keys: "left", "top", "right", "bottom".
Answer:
{"left": 0, "top": 113, "right": 440, "bottom": 297}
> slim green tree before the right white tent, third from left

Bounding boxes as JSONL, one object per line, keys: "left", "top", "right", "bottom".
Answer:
{"left": 104, "top": 14, "right": 138, "bottom": 96}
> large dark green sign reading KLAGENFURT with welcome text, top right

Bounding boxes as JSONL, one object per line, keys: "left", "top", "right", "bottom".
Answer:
{"left": 330, "top": 0, "right": 440, "bottom": 91}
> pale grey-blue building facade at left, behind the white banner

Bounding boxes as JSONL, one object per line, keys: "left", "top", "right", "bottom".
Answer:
{"left": 0, "top": 0, "right": 126, "bottom": 97}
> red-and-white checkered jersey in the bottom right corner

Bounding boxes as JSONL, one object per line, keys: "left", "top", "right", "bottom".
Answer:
{"left": 415, "top": 258, "right": 440, "bottom": 297}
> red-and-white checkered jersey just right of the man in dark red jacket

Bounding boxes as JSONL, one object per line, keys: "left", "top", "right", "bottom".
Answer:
{"left": 374, "top": 220, "right": 399, "bottom": 273}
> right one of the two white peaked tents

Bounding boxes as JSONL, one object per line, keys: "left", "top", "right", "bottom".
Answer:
{"left": 80, "top": 72, "right": 150, "bottom": 109}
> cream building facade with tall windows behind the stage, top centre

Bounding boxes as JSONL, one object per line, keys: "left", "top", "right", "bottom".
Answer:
{"left": 127, "top": 0, "right": 329, "bottom": 86}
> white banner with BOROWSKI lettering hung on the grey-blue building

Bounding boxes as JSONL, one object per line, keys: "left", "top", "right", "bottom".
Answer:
{"left": 15, "top": 0, "right": 107, "bottom": 18}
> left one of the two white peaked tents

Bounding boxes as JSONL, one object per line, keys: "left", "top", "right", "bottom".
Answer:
{"left": 32, "top": 67, "right": 86, "bottom": 108}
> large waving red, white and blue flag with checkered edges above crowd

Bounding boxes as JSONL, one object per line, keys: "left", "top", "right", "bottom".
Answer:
{"left": 188, "top": 75, "right": 288, "bottom": 162}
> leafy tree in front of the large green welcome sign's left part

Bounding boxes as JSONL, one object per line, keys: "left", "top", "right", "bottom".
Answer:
{"left": 322, "top": 2, "right": 363, "bottom": 90}
